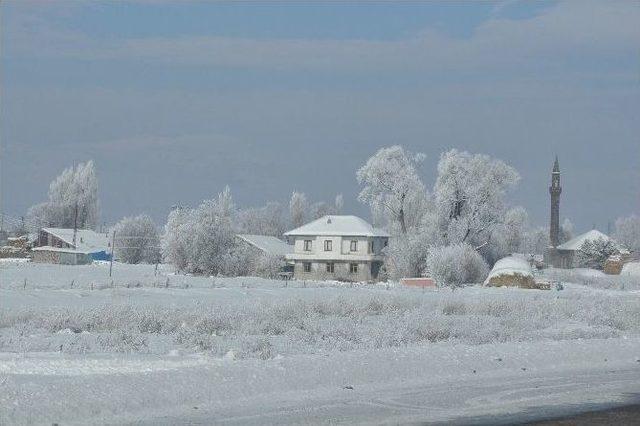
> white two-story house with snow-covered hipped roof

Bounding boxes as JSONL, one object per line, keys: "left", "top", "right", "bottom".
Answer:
{"left": 284, "top": 215, "right": 389, "bottom": 281}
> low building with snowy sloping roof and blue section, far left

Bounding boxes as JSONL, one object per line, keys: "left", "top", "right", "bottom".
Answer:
{"left": 32, "top": 228, "right": 111, "bottom": 265}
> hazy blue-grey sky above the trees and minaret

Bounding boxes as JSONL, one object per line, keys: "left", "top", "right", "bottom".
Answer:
{"left": 0, "top": 0, "right": 640, "bottom": 231}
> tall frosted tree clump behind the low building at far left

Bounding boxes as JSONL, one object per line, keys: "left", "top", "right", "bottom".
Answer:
{"left": 27, "top": 161, "right": 99, "bottom": 231}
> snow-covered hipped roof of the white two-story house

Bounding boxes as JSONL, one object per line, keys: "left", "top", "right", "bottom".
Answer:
{"left": 284, "top": 215, "right": 389, "bottom": 237}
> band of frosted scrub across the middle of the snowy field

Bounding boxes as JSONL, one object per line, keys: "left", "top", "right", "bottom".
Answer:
{"left": 5, "top": 281, "right": 640, "bottom": 359}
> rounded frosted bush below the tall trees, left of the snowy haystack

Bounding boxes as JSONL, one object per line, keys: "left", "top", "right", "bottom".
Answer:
{"left": 427, "top": 244, "right": 489, "bottom": 287}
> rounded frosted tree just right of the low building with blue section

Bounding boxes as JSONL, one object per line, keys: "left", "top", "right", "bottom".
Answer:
{"left": 114, "top": 215, "right": 160, "bottom": 263}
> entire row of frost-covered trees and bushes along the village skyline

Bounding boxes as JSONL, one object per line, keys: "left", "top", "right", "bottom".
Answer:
{"left": 26, "top": 156, "right": 640, "bottom": 283}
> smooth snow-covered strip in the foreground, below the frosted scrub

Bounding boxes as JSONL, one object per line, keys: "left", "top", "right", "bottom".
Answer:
{"left": 0, "top": 338, "right": 640, "bottom": 425}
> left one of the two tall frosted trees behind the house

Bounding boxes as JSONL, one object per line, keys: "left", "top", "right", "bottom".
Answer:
{"left": 356, "top": 145, "right": 426, "bottom": 234}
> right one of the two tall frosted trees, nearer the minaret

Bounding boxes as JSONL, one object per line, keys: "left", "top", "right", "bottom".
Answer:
{"left": 433, "top": 149, "right": 519, "bottom": 253}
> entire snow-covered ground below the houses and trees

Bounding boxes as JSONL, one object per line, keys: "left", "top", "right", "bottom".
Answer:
{"left": 0, "top": 262, "right": 640, "bottom": 424}
